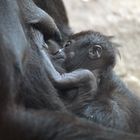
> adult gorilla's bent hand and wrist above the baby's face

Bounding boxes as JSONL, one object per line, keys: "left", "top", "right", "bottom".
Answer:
{"left": 21, "top": 0, "right": 61, "bottom": 41}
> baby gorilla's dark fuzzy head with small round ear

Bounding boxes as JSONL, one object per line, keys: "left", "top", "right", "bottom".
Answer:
{"left": 62, "top": 31, "right": 117, "bottom": 71}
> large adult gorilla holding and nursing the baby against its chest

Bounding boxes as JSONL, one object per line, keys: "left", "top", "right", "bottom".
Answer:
{"left": 0, "top": 0, "right": 140, "bottom": 140}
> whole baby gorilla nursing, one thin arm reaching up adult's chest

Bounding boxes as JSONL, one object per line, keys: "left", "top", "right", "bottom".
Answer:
{"left": 42, "top": 31, "right": 140, "bottom": 133}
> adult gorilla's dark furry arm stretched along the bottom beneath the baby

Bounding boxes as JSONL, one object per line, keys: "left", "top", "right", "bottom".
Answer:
{"left": 0, "top": 107, "right": 140, "bottom": 140}
